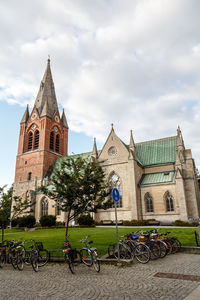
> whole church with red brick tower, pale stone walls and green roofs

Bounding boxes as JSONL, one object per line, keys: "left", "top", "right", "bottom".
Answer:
{"left": 14, "top": 59, "right": 200, "bottom": 223}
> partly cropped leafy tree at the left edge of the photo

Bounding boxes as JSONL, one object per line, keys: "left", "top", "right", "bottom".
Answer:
{"left": 0, "top": 186, "right": 35, "bottom": 241}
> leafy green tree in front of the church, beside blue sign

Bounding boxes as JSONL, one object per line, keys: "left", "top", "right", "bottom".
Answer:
{"left": 40, "top": 156, "right": 112, "bottom": 239}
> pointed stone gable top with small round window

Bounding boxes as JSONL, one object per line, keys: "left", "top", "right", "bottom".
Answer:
{"left": 99, "top": 128, "right": 129, "bottom": 164}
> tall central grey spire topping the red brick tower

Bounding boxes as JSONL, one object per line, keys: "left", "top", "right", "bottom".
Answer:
{"left": 35, "top": 59, "right": 58, "bottom": 118}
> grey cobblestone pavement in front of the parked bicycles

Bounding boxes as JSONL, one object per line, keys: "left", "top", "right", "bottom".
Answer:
{"left": 0, "top": 253, "right": 200, "bottom": 300}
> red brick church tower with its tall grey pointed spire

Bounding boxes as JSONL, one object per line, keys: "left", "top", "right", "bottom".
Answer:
{"left": 14, "top": 59, "right": 68, "bottom": 219}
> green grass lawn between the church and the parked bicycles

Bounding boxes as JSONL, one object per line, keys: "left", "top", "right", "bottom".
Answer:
{"left": 1, "top": 227, "right": 197, "bottom": 256}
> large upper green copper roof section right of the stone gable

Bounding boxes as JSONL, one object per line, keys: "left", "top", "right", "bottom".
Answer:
{"left": 136, "top": 136, "right": 176, "bottom": 166}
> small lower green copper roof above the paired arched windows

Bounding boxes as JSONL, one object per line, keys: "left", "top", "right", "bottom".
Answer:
{"left": 140, "top": 171, "right": 175, "bottom": 186}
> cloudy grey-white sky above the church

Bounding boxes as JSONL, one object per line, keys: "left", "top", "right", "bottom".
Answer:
{"left": 0, "top": 0, "right": 200, "bottom": 185}
